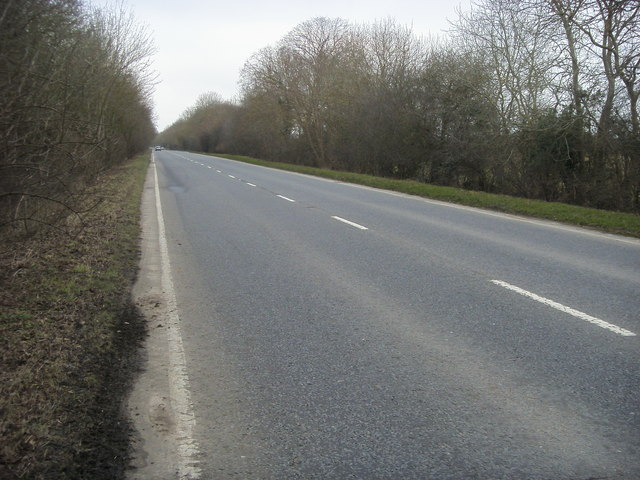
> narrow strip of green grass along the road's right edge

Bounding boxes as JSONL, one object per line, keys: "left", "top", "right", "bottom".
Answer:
{"left": 208, "top": 154, "right": 640, "bottom": 238}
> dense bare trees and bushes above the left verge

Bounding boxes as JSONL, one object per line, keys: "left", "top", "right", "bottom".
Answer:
{"left": 0, "top": 0, "right": 156, "bottom": 235}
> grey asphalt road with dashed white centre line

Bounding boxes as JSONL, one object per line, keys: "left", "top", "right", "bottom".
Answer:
{"left": 132, "top": 151, "right": 640, "bottom": 480}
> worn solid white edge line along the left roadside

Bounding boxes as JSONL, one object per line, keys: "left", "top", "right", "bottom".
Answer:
{"left": 152, "top": 160, "right": 202, "bottom": 480}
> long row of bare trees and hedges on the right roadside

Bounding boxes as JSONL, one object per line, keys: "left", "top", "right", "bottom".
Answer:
{"left": 158, "top": 0, "right": 640, "bottom": 212}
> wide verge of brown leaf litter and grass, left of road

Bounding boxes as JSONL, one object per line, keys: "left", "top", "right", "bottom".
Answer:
{"left": 0, "top": 155, "right": 148, "bottom": 479}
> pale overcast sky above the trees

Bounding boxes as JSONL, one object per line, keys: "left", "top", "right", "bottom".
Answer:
{"left": 93, "top": 0, "right": 476, "bottom": 131}
